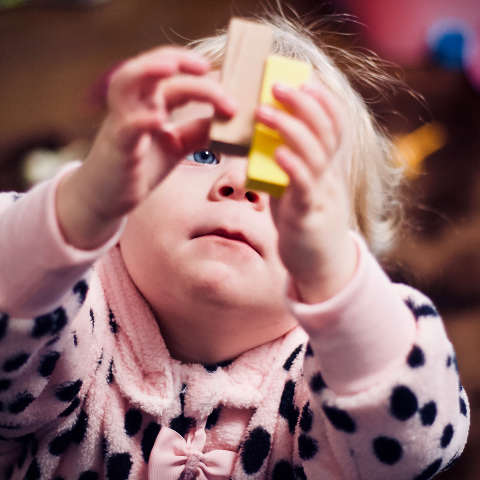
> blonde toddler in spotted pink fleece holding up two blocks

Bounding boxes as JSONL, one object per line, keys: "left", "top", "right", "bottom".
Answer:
{"left": 0, "top": 13, "right": 469, "bottom": 480}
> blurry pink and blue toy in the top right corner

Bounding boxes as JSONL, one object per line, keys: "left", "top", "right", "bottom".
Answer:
{"left": 339, "top": 0, "right": 480, "bottom": 91}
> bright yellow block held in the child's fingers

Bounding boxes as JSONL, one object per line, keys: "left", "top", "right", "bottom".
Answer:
{"left": 245, "top": 55, "right": 311, "bottom": 197}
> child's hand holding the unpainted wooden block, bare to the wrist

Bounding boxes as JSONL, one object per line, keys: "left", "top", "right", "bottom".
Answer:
{"left": 56, "top": 47, "right": 236, "bottom": 249}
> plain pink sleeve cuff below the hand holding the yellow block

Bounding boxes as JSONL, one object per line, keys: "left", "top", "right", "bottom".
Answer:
{"left": 287, "top": 233, "right": 416, "bottom": 395}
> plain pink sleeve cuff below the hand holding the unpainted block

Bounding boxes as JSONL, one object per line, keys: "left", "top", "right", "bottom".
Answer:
{"left": 0, "top": 162, "right": 125, "bottom": 318}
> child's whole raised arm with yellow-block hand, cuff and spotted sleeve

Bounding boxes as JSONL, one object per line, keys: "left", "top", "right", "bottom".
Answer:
{"left": 258, "top": 84, "right": 469, "bottom": 480}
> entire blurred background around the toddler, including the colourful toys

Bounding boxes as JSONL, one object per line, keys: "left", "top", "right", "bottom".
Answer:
{"left": 0, "top": 0, "right": 480, "bottom": 480}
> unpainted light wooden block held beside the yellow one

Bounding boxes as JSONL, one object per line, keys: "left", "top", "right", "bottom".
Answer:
{"left": 210, "top": 18, "right": 272, "bottom": 155}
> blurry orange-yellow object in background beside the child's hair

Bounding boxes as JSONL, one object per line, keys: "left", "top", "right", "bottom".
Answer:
{"left": 395, "top": 122, "right": 447, "bottom": 178}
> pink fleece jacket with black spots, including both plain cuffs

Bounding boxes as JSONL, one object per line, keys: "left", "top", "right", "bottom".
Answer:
{"left": 0, "top": 165, "right": 469, "bottom": 480}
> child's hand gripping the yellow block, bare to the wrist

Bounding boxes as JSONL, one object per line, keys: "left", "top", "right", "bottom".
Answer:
{"left": 256, "top": 82, "right": 357, "bottom": 303}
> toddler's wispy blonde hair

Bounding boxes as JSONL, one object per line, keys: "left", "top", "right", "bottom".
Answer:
{"left": 189, "top": 13, "right": 402, "bottom": 256}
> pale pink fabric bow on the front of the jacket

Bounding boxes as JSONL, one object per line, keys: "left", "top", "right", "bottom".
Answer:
{"left": 148, "top": 418, "right": 237, "bottom": 480}
